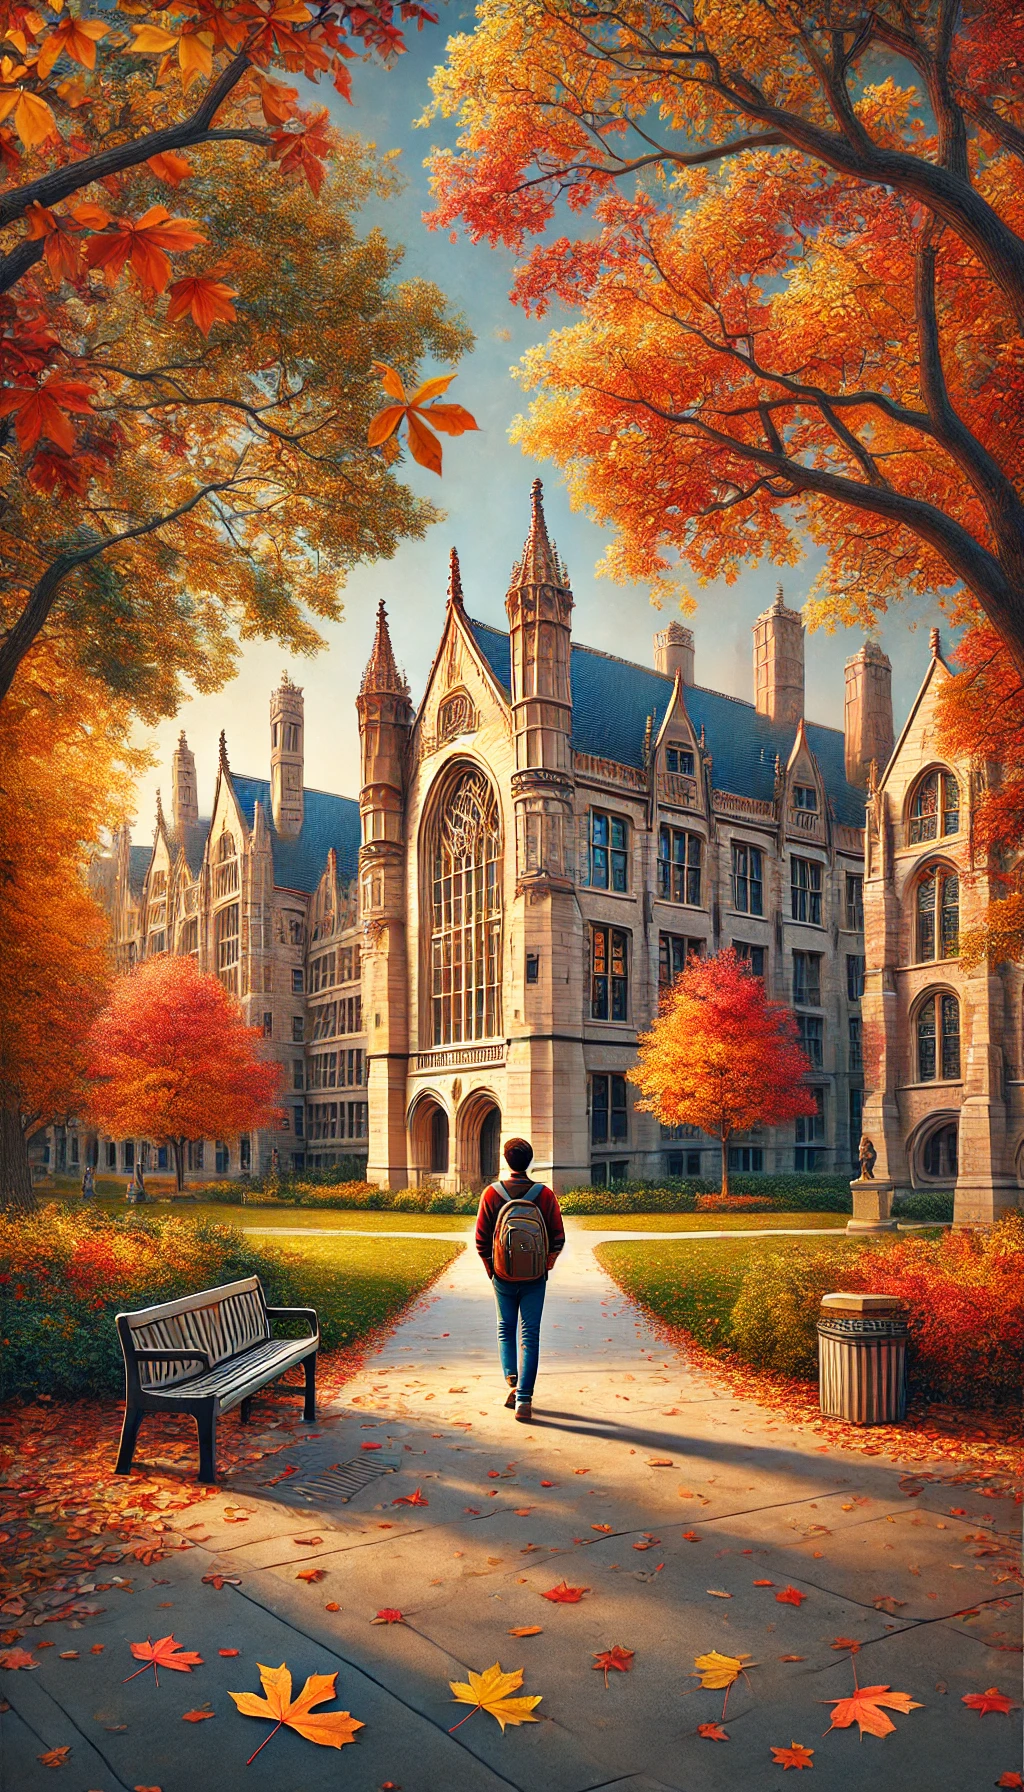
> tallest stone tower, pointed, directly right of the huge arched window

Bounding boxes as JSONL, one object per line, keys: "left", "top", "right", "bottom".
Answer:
{"left": 506, "top": 480, "right": 590, "bottom": 1188}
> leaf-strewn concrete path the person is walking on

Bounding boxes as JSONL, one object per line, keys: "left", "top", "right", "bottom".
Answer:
{"left": 0, "top": 1233, "right": 1020, "bottom": 1792}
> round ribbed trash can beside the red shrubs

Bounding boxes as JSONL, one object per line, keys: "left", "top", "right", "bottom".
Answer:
{"left": 818, "top": 1294, "right": 907, "bottom": 1425}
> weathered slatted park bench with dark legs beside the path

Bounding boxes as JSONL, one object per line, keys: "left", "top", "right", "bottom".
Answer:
{"left": 115, "top": 1276, "right": 319, "bottom": 1482}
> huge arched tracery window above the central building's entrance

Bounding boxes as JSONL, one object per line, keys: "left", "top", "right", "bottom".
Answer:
{"left": 430, "top": 767, "right": 502, "bottom": 1045}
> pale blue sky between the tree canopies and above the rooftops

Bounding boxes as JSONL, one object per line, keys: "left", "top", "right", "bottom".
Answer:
{"left": 135, "top": 5, "right": 947, "bottom": 839}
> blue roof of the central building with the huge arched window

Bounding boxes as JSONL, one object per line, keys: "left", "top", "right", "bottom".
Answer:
{"left": 470, "top": 622, "right": 864, "bottom": 828}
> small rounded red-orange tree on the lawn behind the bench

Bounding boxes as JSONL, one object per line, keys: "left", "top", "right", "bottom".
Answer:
{"left": 90, "top": 957, "right": 282, "bottom": 1188}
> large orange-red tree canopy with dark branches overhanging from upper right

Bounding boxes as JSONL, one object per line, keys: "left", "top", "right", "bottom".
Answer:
{"left": 432, "top": 0, "right": 1024, "bottom": 672}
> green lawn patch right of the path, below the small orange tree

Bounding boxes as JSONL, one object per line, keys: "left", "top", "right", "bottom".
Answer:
{"left": 594, "top": 1240, "right": 864, "bottom": 1346}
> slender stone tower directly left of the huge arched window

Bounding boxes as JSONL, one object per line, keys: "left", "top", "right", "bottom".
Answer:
{"left": 355, "top": 604, "right": 412, "bottom": 1188}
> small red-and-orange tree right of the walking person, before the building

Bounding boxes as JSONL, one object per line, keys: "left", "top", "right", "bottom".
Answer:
{"left": 629, "top": 946, "right": 816, "bottom": 1195}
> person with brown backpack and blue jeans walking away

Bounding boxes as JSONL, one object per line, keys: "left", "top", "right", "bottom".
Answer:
{"left": 477, "top": 1138, "right": 565, "bottom": 1425}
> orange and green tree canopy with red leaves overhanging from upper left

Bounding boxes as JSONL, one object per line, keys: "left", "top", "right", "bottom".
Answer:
{"left": 0, "top": 0, "right": 468, "bottom": 715}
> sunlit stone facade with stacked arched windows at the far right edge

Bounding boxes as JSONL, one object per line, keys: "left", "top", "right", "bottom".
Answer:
{"left": 863, "top": 631, "right": 1024, "bottom": 1226}
